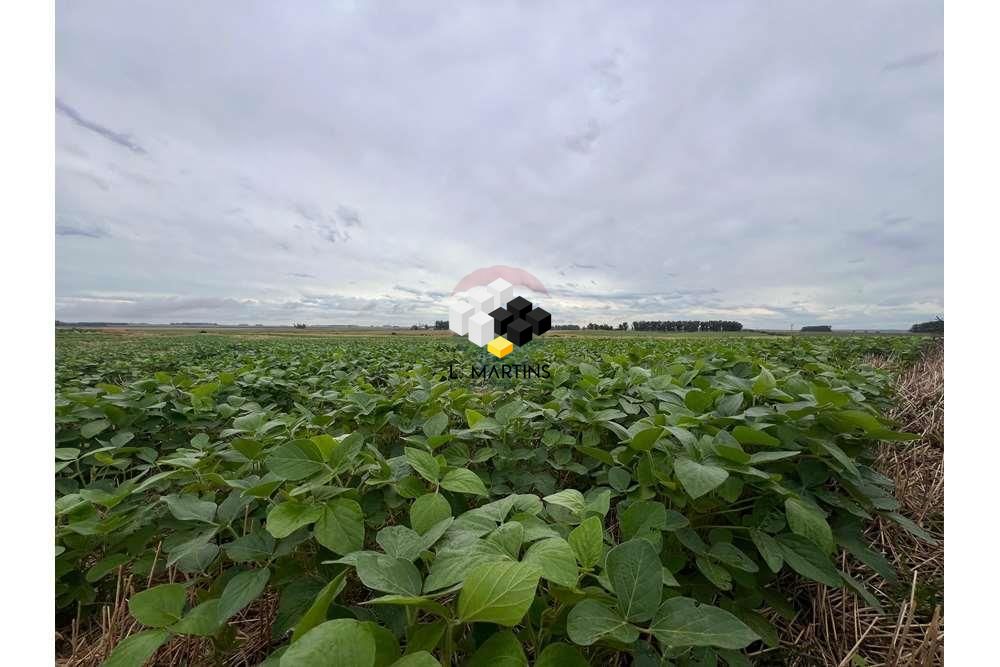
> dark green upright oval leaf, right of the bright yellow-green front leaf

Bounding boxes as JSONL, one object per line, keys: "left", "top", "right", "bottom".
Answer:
{"left": 605, "top": 539, "right": 663, "bottom": 622}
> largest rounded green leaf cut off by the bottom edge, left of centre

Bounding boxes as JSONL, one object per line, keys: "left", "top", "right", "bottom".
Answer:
{"left": 280, "top": 618, "right": 376, "bottom": 667}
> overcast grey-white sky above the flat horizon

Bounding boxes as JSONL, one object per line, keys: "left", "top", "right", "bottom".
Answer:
{"left": 55, "top": 0, "right": 944, "bottom": 328}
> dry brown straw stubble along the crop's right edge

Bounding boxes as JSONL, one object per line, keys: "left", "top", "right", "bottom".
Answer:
{"left": 775, "top": 340, "right": 944, "bottom": 667}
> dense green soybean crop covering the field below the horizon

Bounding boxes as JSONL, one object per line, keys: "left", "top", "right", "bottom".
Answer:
{"left": 55, "top": 328, "right": 943, "bottom": 665}
